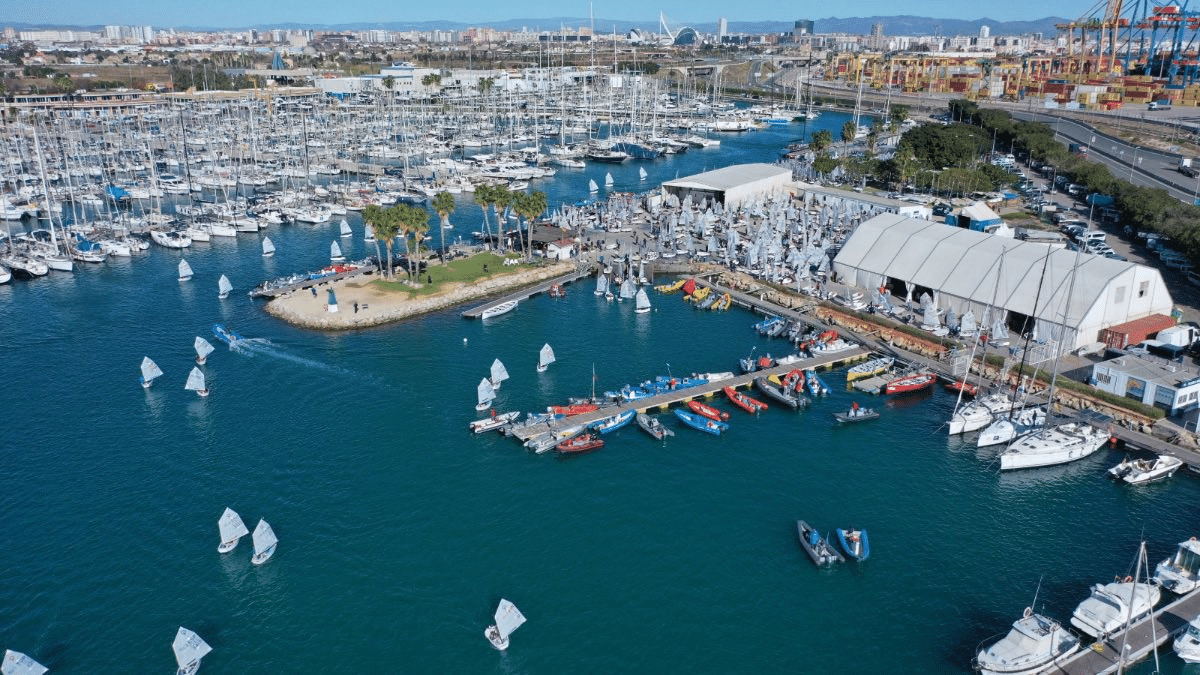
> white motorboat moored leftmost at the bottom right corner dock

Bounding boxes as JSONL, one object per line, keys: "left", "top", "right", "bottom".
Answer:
{"left": 971, "top": 608, "right": 1079, "bottom": 675}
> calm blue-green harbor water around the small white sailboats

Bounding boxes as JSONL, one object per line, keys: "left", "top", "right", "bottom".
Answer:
{"left": 0, "top": 113, "right": 1200, "bottom": 674}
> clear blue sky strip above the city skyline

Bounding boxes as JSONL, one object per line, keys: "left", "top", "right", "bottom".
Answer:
{"left": 9, "top": 0, "right": 1094, "bottom": 29}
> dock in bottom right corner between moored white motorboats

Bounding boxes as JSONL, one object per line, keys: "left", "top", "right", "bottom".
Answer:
{"left": 1052, "top": 581, "right": 1200, "bottom": 675}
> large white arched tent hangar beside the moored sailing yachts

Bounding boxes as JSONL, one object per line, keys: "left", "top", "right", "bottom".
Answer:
{"left": 833, "top": 214, "right": 1172, "bottom": 350}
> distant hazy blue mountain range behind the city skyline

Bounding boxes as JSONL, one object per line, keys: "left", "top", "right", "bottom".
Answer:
{"left": 0, "top": 16, "right": 1067, "bottom": 36}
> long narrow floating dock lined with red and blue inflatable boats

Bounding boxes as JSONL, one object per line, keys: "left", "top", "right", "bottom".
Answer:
{"left": 515, "top": 347, "right": 870, "bottom": 442}
